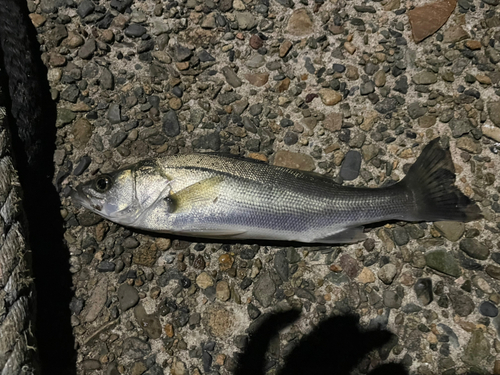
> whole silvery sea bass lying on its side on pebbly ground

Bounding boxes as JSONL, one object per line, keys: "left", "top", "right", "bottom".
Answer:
{"left": 72, "top": 138, "right": 481, "bottom": 244}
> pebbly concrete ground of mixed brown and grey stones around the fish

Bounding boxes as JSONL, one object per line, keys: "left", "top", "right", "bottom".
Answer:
{"left": 28, "top": 0, "right": 500, "bottom": 375}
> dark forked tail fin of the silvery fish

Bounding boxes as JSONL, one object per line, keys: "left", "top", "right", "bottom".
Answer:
{"left": 398, "top": 138, "right": 482, "bottom": 221}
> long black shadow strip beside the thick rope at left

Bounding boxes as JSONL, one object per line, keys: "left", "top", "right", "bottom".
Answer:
{"left": 0, "top": 0, "right": 76, "bottom": 375}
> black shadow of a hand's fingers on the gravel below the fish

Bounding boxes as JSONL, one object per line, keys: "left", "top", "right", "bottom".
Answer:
{"left": 235, "top": 310, "right": 408, "bottom": 375}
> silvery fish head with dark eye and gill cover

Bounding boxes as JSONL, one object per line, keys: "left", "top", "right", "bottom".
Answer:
{"left": 71, "top": 162, "right": 169, "bottom": 225}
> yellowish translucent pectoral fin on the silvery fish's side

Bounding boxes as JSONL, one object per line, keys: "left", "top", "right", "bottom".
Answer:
{"left": 164, "top": 176, "right": 224, "bottom": 213}
